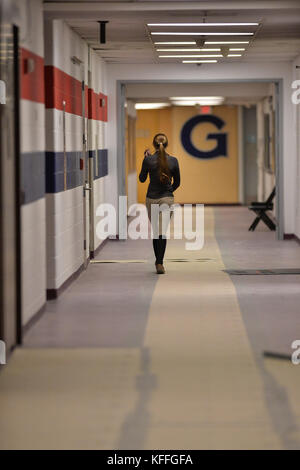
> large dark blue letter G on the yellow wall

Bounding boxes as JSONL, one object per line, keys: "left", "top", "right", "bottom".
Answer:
{"left": 181, "top": 114, "right": 227, "bottom": 158}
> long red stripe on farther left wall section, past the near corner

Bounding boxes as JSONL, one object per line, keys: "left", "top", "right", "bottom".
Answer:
{"left": 45, "top": 65, "right": 107, "bottom": 121}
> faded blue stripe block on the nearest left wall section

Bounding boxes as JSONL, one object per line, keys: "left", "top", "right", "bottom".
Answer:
{"left": 21, "top": 152, "right": 45, "bottom": 204}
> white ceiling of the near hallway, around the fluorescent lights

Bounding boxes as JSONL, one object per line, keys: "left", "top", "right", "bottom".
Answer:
{"left": 44, "top": 0, "right": 300, "bottom": 63}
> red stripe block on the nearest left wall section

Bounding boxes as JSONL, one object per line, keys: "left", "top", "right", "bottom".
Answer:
{"left": 20, "top": 47, "right": 45, "bottom": 103}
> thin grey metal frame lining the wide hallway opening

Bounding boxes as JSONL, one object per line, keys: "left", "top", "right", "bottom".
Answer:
{"left": 116, "top": 78, "right": 284, "bottom": 240}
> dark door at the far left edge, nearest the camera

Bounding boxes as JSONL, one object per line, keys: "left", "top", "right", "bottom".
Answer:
{"left": 0, "top": 22, "right": 21, "bottom": 352}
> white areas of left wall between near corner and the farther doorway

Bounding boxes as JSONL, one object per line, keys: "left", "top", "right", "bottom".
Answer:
{"left": 45, "top": 20, "right": 88, "bottom": 289}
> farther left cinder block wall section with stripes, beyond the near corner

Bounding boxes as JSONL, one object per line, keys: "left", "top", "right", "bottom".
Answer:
{"left": 45, "top": 20, "right": 108, "bottom": 292}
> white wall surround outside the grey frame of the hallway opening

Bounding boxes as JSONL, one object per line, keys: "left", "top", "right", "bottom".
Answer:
{"left": 108, "top": 62, "right": 296, "bottom": 237}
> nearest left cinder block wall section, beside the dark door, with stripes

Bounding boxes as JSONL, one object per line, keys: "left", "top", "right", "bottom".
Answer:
{"left": 17, "top": 0, "right": 46, "bottom": 324}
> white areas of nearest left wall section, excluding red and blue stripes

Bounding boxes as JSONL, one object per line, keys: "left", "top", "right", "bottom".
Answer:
{"left": 16, "top": 0, "right": 46, "bottom": 325}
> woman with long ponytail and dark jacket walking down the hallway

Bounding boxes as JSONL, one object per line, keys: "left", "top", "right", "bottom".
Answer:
{"left": 139, "top": 134, "right": 180, "bottom": 274}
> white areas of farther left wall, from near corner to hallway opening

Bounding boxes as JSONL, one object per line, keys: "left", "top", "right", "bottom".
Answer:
{"left": 45, "top": 20, "right": 111, "bottom": 289}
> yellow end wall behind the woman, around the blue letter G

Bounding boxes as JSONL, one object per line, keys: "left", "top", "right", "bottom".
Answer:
{"left": 136, "top": 106, "right": 238, "bottom": 204}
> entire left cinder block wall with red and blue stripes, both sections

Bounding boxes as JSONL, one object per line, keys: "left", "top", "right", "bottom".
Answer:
{"left": 15, "top": 7, "right": 110, "bottom": 325}
